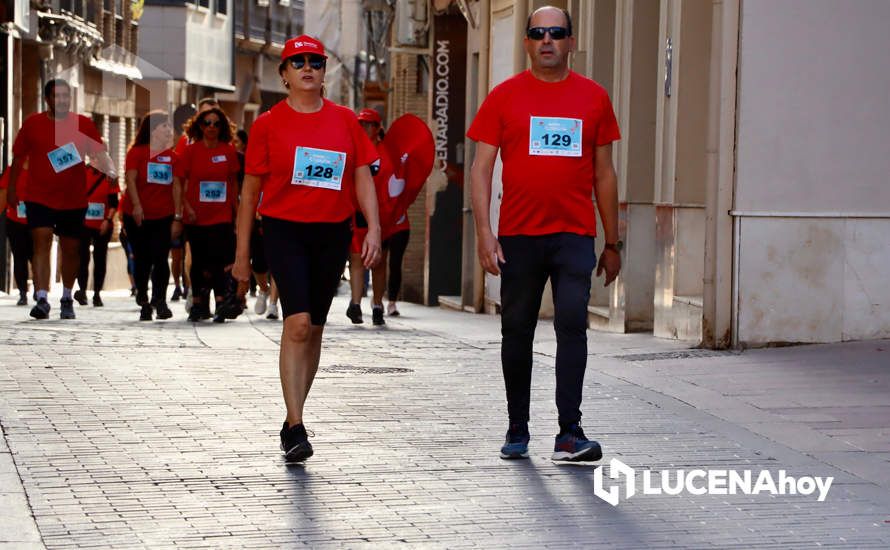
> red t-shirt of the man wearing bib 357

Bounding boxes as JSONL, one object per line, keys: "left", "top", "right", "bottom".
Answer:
{"left": 12, "top": 113, "right": 105, "bottom": 210}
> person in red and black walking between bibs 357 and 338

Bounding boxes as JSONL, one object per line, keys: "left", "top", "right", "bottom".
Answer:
{"left": 74, "top": 165, "right": 120, "bottom": 307}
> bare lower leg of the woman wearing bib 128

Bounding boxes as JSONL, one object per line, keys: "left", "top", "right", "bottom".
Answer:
{"left": 278, "top": 313, "right": 324, "bottom": 426}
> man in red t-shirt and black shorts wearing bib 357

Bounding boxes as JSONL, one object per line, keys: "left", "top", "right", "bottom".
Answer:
{"left": 8, "top": 79, "right": 117, "bottom": 319}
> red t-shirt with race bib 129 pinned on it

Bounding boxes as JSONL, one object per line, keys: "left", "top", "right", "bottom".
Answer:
{"left": 467, "top": 71, "right": 621, "bottom": 235}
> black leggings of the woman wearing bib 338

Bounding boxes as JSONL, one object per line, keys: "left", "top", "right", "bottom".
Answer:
{"left": 124, "top": 214, "right": 173, "bottom": 302}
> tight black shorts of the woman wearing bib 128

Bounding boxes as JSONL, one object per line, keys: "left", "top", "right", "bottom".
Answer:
{"left": 263, "top": 216, "right": 352, "bottom": 326}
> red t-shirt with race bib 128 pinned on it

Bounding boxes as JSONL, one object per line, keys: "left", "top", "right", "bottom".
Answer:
{"left": 244, "top": 99, "right": 377, "bottom": 222}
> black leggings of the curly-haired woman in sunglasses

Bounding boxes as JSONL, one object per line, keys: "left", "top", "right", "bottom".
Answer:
{"left": 185, "top": 223, "right": 235, "bottom": 300}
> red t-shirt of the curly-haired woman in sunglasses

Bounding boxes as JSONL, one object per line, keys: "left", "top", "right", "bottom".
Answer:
{"left": 176, "top": 140, "right": 240, "bottom": 229}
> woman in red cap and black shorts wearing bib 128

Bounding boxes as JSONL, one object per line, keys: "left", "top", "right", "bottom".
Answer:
{"left": 233, "top": 35, "right": 381, "bottom": 462}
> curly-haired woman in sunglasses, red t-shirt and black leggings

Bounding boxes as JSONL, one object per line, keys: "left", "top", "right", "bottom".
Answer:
{"left": 176, "top": 107, "right": 241, "bottom": 322}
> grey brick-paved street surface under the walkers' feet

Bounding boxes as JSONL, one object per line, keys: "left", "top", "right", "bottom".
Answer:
{"left": 0, "top": 294, "right": 890, "bottom": 549}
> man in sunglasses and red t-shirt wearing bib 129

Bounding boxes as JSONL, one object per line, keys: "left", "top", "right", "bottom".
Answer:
{"left": 467, "top": 6, "right": 621, "bottom": 461}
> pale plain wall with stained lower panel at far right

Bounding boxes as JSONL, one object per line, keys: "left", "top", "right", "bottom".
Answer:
{"left": 735, "top": 0, "right": 890, "bottom": 344}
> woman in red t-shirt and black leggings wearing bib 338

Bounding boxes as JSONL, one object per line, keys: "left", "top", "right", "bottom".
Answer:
{"left": 121, "top": 111, "right": 182, "bottom": 321}
